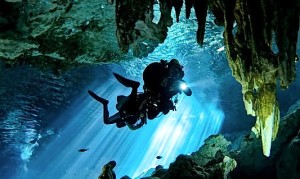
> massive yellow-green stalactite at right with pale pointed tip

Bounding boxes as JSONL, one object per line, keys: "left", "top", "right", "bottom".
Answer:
{"left": 209, "top": 0, "right": 299, "bottom": 156}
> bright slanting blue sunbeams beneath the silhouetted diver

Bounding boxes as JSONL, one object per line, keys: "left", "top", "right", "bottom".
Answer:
{"left": 23, "top": 61, "right": 224, "bottom": 178}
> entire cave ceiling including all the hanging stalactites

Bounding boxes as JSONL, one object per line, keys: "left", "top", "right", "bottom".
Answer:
{"left": 0, "top": 0, "right": 300, "bottom": 156}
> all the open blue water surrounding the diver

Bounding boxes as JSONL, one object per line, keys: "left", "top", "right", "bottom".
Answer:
{"left": 0, "top": 7, "right": 300, "bottom": 179}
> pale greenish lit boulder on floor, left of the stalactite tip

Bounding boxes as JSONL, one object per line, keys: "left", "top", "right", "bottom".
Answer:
{"left": 140, "top": 135, "right": 237, "bottom": 179}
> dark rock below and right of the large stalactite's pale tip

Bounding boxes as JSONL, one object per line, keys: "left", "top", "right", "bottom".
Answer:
{"left": 230, "top": 100, "right": 300, "bottom": 178}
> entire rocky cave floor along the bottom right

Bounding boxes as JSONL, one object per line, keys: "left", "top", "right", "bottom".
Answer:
{"left": 134, "top": 100, "right": 300, "bottom": 179}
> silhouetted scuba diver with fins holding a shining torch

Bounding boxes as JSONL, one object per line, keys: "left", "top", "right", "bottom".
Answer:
{"left": 88, "top": 59, "right": 192, "bottom": 130}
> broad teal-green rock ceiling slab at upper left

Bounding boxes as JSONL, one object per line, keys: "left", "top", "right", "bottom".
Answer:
{"left": 0, "top": 0, "right": 123, "bottom": 71}
